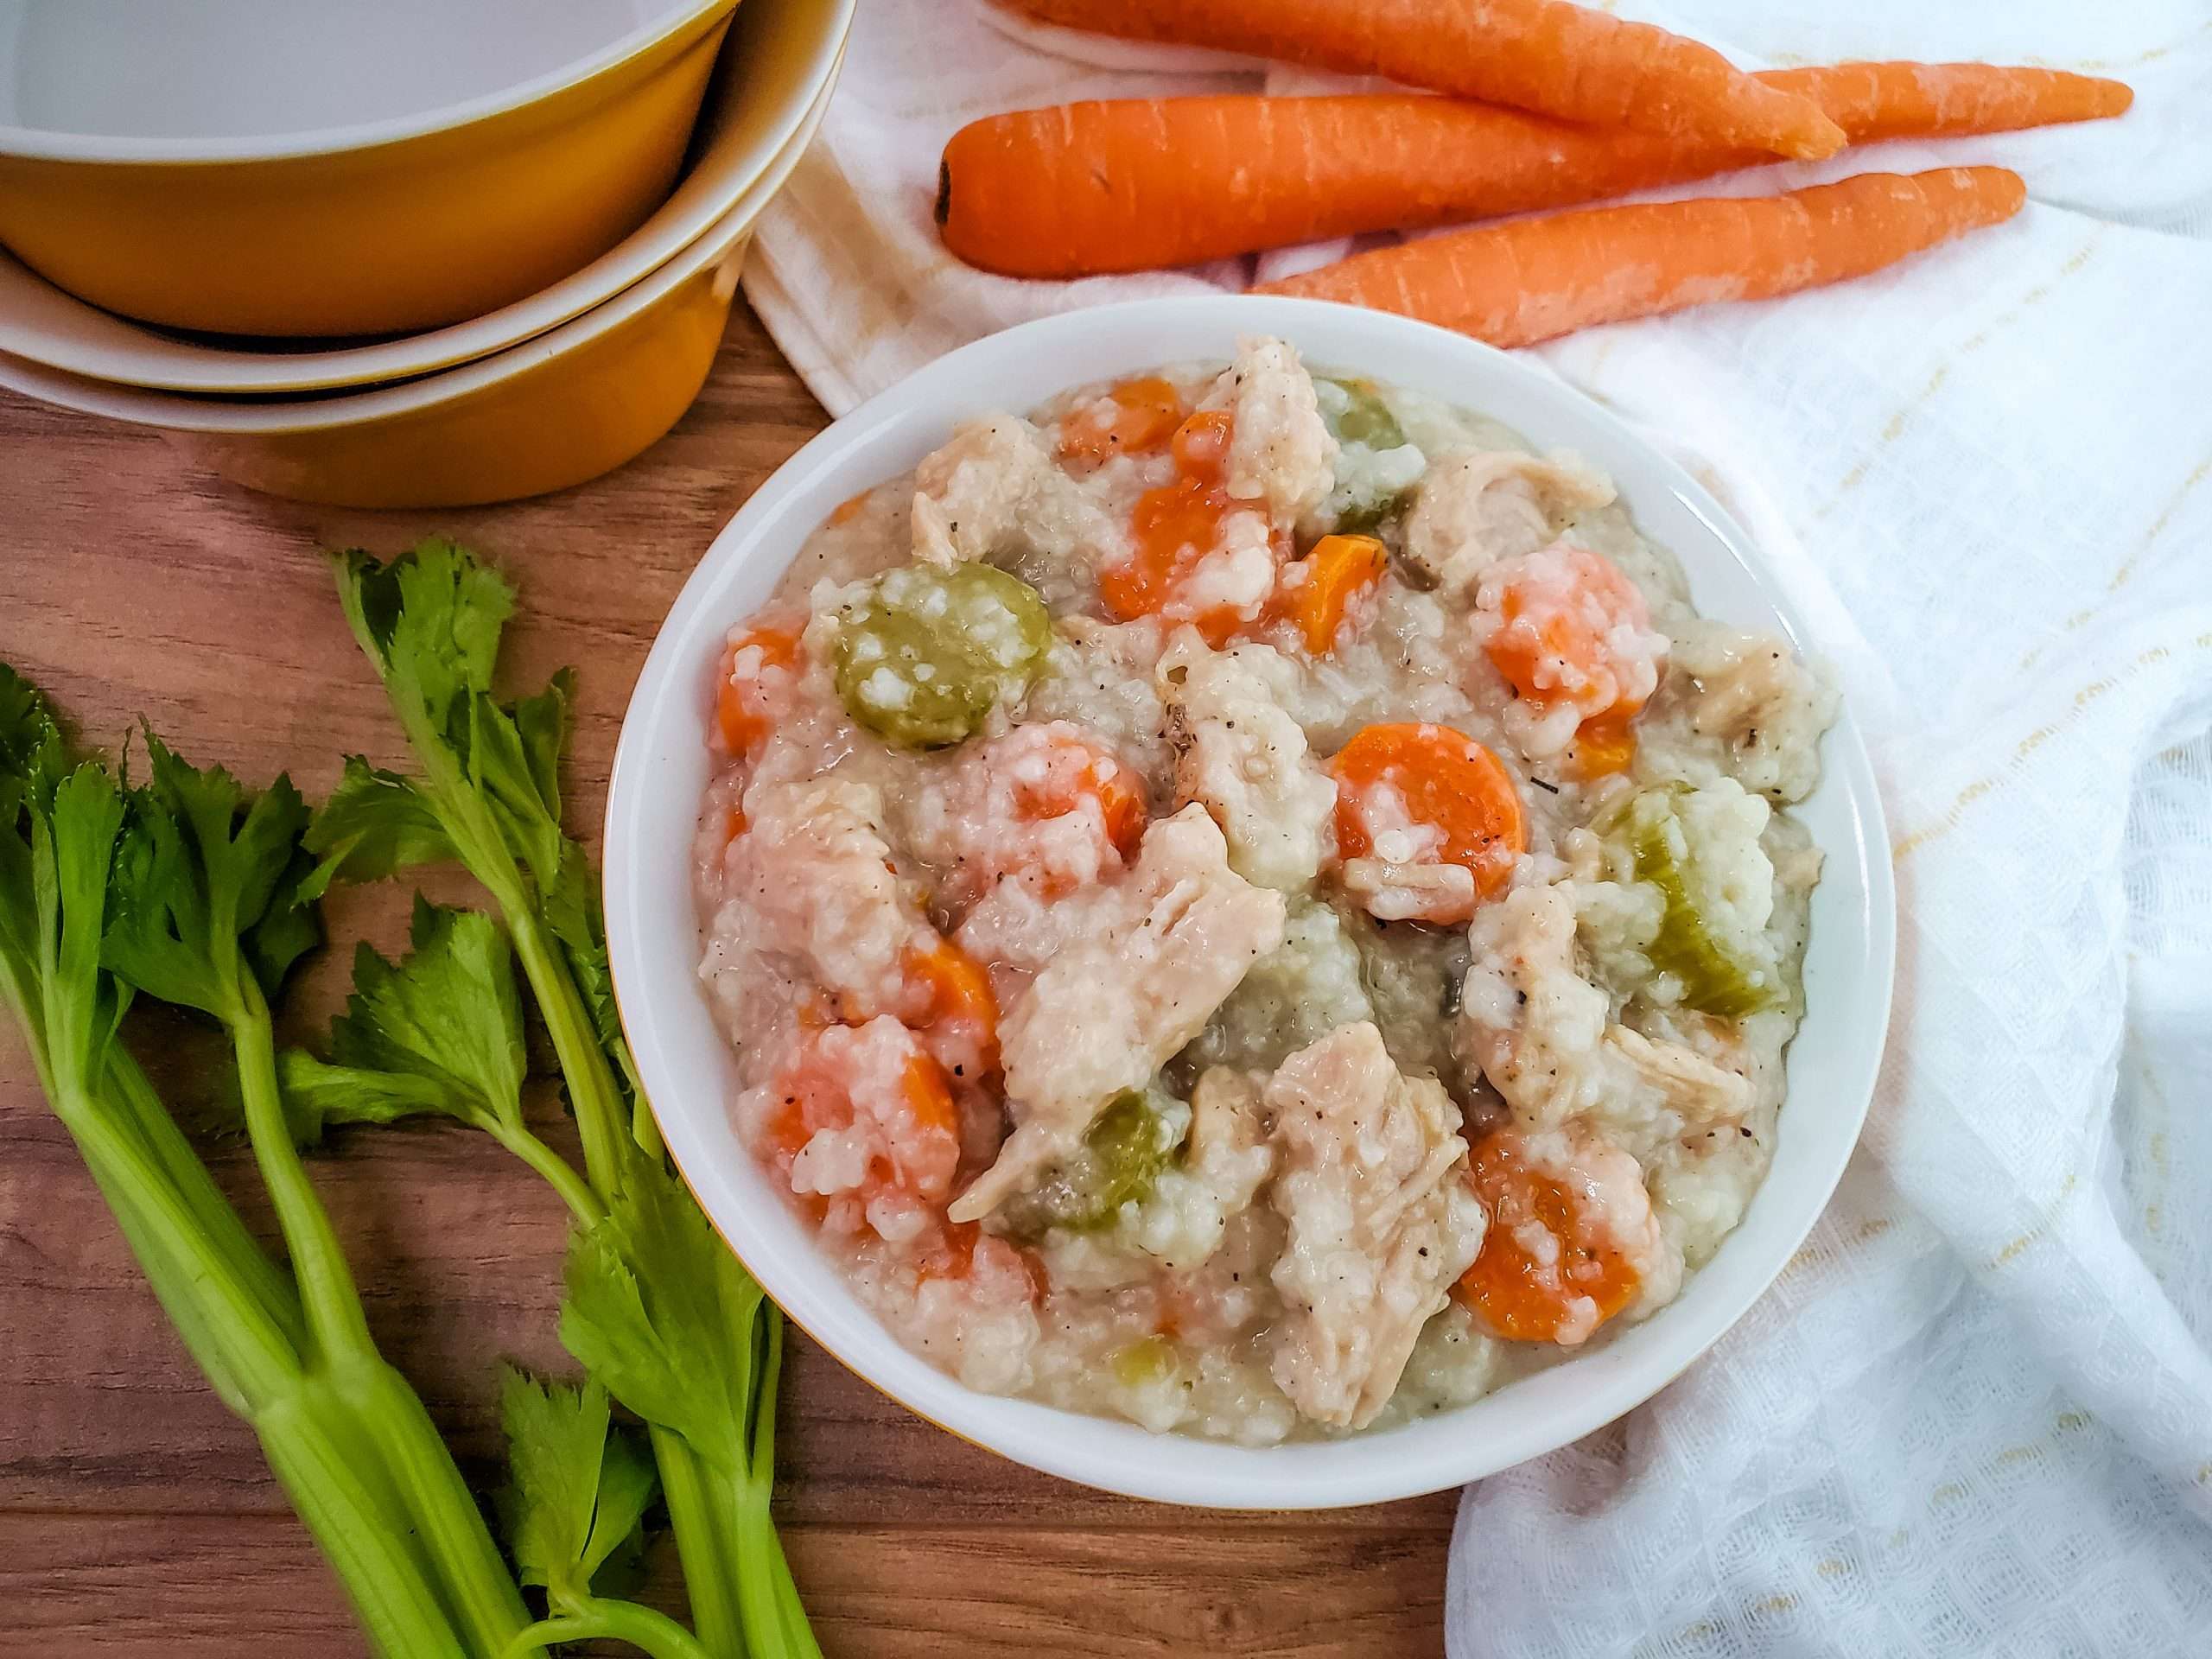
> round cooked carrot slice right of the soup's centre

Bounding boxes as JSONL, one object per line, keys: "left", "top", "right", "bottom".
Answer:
{"left": 1330, "top": 723, "right": 1529, "bottom": 923}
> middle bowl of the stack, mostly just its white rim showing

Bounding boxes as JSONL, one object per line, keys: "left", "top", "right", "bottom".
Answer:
{"left": 0, "top": 0, "right": 856, "bottom": 396}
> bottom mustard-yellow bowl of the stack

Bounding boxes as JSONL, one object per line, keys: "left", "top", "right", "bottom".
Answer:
{"left": 0, "top": 55, "right": 836, "bottom": 506}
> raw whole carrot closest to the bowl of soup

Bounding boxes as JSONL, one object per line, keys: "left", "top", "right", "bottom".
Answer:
{"left": 1259, "top": 168, "right": 2026, "bottom": 345}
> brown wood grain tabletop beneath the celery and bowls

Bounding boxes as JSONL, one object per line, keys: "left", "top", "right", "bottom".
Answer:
{"left": 0, "top": 308, "right": 1451, "bottom": 1659}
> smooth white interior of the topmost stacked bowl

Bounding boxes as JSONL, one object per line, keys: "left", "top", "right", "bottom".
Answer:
{"left": 0, "top": 0, "right": 690, "bottom": 139}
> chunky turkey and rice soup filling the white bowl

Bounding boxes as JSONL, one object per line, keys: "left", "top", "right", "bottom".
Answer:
{"left": 695, "top": 339, "right": 1836, "bottom": 1445}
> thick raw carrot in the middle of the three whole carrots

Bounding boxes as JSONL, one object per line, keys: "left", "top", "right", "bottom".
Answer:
{"left": 938, "top": 64, "right": 2133, "bottom": 276}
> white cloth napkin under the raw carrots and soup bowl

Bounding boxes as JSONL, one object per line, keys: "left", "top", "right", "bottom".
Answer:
{"left": 746, "top": 0, "right": 2212, "bottom": 1659}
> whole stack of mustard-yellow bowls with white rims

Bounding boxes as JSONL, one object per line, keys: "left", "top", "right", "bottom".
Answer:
{"left": 0, "top": 0, "right": 854, "bottom": 506}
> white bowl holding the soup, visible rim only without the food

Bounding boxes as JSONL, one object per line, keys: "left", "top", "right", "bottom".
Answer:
{"left": 606, "top": 296, "right": 1896, "bottom": 1509}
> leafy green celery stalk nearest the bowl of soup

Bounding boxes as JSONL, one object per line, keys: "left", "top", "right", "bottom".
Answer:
{"left": 314, "top": 542, "right": 818, "bottom": 1659}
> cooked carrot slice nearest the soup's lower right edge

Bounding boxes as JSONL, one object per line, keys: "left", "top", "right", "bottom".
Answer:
{"left": 1458, "top": 1130, "right": 1642, "bottom": 1343}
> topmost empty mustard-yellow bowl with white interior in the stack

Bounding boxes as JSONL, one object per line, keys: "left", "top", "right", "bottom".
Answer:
{"left": 0, "top": 0, "right": 736, "bottom": 336}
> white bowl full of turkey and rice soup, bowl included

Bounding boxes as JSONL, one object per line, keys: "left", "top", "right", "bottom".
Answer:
{"left": 606, "top": 296, "right": 1893, "bottom": 1509}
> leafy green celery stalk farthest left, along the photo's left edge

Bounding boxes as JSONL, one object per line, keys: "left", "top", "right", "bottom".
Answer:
{"left": 0, "top": 666, "right": 526, "bottom": 1659}
